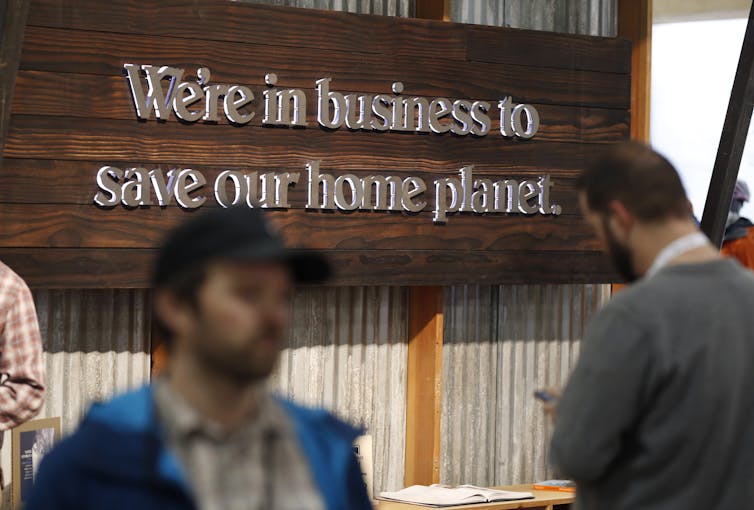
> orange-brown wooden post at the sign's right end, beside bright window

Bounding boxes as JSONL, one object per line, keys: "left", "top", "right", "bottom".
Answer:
{"left": 618, "top": 0, "right": 652, "bottom": 142}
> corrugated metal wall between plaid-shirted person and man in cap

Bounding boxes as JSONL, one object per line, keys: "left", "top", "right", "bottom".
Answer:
{"left": 0, "top": 289, "right": 150, "bottom": 508}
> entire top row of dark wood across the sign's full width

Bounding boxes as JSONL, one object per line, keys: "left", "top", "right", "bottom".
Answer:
{"left": 29, "top": 0, "right": 631, "bottom": 74}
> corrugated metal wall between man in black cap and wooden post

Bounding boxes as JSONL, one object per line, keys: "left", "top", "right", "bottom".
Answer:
{"left": 271, "top": 287, "right": 408, "bottom": 491}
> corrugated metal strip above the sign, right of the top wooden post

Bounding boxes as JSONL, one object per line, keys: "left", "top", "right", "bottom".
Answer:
{"left": 450, "top": 0, "right": 618, "bottom": 37}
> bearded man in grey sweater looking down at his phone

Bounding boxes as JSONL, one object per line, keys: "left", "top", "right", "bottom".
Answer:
{"left": 551, "top": 143, "right": 754, "bottom": 510}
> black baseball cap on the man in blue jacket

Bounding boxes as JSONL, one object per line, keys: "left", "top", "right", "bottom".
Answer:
{"left": 152, "top": 206, "right": 330, "bottom": 287}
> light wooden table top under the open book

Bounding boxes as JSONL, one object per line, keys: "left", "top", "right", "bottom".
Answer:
{"left": 377, "top": 484, "right": 576, "bottom": 510}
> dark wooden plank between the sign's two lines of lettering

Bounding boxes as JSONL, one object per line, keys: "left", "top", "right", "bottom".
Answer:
{"left": 0, "top": 115, "right": 619, "bottom": 165}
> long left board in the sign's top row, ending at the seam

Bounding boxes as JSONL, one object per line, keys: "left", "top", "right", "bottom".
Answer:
{"left": 29, "top": 0, "right": 465, "bottom": 60}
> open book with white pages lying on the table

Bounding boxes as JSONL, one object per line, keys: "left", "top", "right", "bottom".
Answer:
{"left": 380, "top": 484, "right": 534, "bottom": 507}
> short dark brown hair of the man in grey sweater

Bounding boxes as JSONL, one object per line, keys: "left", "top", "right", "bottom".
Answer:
{"left": 576, "top": 142, "right": 692, "bottom": 222}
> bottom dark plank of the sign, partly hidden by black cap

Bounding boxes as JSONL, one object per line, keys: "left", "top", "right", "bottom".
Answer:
{"left": 0, "top": 248, "right": 620, "bottom": 288}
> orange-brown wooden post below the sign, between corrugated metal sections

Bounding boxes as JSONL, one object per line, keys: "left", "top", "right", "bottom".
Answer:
{"left": 404, "top": 286, "right": 443, "bottom": 487}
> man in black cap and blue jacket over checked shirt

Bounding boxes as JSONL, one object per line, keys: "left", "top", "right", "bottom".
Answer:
{"left": 26, "top": 208, "right": 371, "bottom": 510}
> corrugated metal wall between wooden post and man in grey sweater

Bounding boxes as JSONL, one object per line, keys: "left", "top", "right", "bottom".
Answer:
{"left": 440, "top": 285, "right": 610, "bottom": 485}
